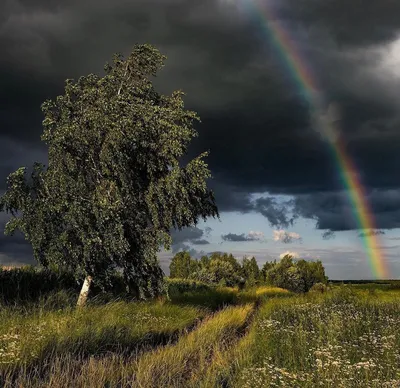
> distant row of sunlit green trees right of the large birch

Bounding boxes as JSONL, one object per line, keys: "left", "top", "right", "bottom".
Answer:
{"left": 169, "top": 251, "right": 328, "bottom": 292}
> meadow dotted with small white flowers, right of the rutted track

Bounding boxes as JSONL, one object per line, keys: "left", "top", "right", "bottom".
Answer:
{"left": 232, "top": 286, "right": 400, "bottom": 388}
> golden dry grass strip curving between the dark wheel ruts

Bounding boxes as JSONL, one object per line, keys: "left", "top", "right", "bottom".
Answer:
{"left": 3, "top": 305, "right": 252, "bottom": 388}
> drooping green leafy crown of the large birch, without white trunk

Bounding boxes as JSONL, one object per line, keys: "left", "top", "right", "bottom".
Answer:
{"left": 0, "top": 45, "right": 218, "bottom": 298}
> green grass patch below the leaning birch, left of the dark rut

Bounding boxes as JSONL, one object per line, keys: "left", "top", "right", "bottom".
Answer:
{"left": 0, "top": 301, "right": 206, "bottom": 373}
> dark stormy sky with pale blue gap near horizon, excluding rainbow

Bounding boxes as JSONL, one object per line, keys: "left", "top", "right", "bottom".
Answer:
{"left": 0, "top": 0, "right": 400, "bottom": 279}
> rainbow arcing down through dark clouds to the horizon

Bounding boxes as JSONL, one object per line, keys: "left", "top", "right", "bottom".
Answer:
{"left": 238, "top": 0, "right": 388, "bottom": 279}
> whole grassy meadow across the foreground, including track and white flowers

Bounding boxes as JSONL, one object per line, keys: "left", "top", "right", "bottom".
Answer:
{"left": 0, "top": 283, "right": 400, "bottom": 388}
